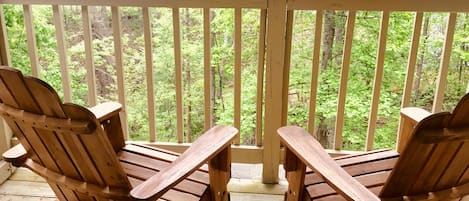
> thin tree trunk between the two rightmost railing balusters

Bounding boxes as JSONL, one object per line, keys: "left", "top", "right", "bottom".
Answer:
{"left": 413, "top": 15, "right": 430, "bottom": 101}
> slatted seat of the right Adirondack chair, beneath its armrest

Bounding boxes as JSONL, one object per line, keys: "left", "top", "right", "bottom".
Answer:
{"left": 304, "top": 150, "right": 399, "bottom": 201}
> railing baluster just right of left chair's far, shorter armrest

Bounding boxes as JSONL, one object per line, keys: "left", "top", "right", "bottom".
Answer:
{"left": 111, "top": 6, "right": 128, "bottom": 139}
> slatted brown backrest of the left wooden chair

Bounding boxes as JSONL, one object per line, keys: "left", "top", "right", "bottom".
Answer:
{"left": 0, "top": 67, "right": 130, "bottom": 200}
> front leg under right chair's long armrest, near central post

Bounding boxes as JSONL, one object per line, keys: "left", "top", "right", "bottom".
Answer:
{"left": 284, "top": 148, "right": 306, "bottom": 201}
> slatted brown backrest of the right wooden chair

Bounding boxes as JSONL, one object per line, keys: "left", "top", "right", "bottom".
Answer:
{"left": 381, "top": 94, "right": 469, "bottom": 197}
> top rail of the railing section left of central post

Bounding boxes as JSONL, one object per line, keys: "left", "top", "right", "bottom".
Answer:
{"left": 0, "top": 0, "right": 267, "bottom": 9}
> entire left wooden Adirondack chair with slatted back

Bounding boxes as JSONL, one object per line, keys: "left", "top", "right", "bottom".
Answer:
{"left": 0, "top": 66, "right": 237, "bottom": 200}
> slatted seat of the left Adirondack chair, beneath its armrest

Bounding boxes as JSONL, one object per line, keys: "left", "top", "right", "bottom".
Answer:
{"left": 117, "top": 144, "right": 210, "bottom": 201}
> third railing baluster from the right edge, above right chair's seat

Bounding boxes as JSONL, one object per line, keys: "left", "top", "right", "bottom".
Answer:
{"left": 365, "top": 11, "right": 389, "bottom": 151}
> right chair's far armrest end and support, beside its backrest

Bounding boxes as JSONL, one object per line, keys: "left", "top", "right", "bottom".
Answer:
{"left": 397, "top": 107, "right": 432, "bottom": 153}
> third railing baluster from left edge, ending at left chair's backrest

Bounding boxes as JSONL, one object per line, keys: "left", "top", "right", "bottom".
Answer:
{"left": 52, "top": 5, "right": 72, "bottom": 102}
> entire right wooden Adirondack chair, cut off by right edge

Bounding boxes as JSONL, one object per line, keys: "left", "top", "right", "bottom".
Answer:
{"left": 278, "top": 94, "right": 469, "bottom": 201}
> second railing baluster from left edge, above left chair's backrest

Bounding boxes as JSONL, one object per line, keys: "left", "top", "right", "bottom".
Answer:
{"left": 23, "top": 5, "right": 40, "bottom": 77}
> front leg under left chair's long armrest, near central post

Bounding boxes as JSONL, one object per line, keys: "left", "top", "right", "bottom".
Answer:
{"left": 208, "top": 146, "right": 231, "bottom": 201}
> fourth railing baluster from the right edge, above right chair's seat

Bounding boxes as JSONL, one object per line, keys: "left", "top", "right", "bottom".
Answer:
{"left": 334, "top": 11, "right": 356, "bottom": 150}
